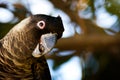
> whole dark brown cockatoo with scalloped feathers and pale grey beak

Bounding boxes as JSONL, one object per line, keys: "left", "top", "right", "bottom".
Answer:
{"left": 0, "top": 14, "right": 64, "bottom": 80}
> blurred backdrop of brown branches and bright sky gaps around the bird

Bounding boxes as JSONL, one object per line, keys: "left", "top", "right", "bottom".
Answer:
{"left": 0, "top": 0, "right": 120, "bottom": 80}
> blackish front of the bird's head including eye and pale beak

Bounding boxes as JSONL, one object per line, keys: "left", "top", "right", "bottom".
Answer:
{"left": 31, "top": 15, "right": 64, "bottom": 57}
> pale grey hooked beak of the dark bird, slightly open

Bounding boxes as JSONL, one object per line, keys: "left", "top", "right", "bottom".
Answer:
{"left": 32, "top": 33, "right": 57, "bottom": 57}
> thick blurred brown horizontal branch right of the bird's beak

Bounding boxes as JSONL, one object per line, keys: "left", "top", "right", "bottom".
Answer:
{"left": 56, "top": 35, "right": 120, "bottom": 53}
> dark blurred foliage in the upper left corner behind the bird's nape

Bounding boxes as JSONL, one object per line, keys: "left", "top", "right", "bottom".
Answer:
{"left": 0, "top": 2, "right": 31, "bottom": 39}
